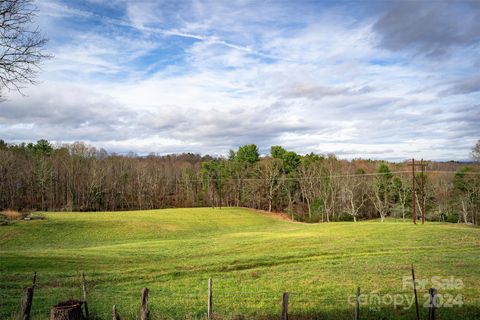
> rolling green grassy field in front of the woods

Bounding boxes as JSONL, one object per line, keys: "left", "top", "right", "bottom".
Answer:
{"left": 0, "top": 208, "right": 480, "bottom": 320}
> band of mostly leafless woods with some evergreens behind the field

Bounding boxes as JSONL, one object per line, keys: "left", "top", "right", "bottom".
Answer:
{"left": 0, "top": 140, "right": 480, "bottom": 224}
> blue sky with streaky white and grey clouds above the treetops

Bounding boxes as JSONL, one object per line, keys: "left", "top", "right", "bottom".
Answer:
{"left": 0, "top": 0, "right": 480, "bottom": 160}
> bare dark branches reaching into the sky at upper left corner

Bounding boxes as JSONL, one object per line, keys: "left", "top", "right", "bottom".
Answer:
{"left": 0, "top": 0, "right": 50, "bottom": 99}
